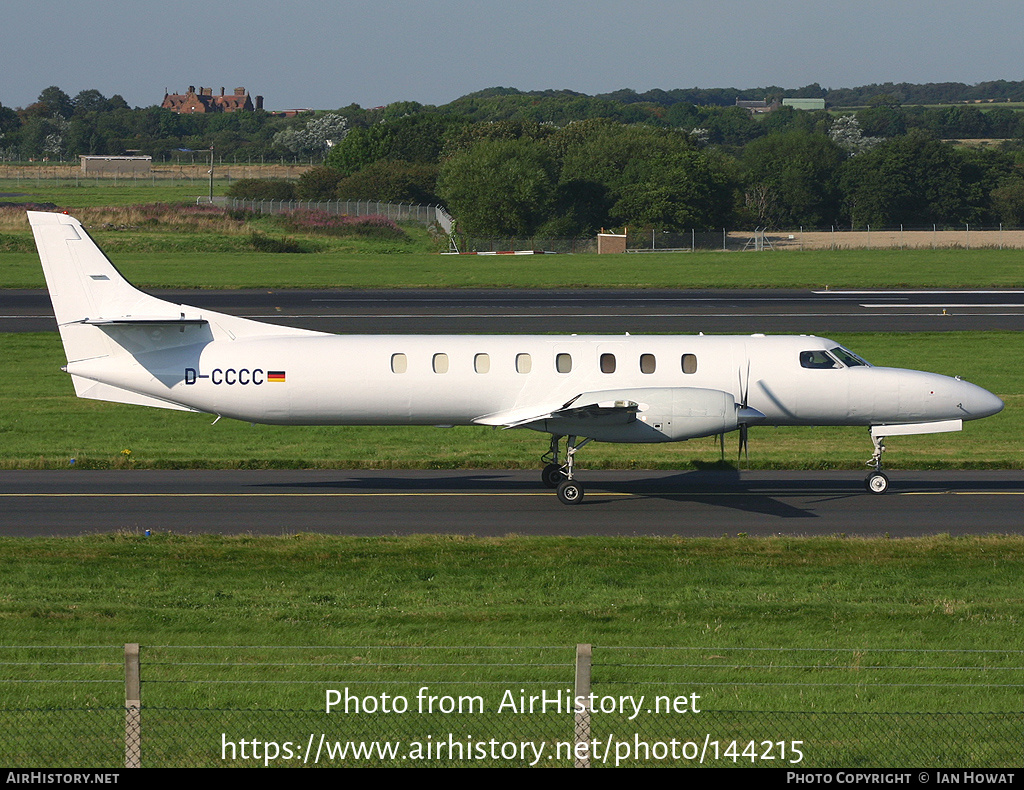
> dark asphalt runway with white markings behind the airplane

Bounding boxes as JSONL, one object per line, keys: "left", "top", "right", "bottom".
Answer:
{"left": 6, "top": 289, "right": 1024, "bottom": 335}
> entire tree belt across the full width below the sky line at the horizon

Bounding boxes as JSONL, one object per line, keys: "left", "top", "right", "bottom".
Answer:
{"left": 6, "top": 86, "right": 1024, "bottom": 237}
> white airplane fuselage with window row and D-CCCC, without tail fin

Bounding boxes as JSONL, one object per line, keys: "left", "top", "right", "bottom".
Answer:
{"left": 61, "top": 328, "right": 998, "bottom": 442}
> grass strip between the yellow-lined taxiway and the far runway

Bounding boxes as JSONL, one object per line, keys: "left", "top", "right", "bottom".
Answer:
{"left": 0, "top": 332, "right": 1024, "bottom": 469}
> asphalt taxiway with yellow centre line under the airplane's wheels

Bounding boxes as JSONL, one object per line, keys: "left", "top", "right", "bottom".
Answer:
{"left": 0, "top": 469, "right": 1024, "bottom": 538}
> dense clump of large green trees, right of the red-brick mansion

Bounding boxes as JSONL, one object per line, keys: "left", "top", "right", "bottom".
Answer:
{"left": 307, "top": 96, "right": 1024, "bottom": 237}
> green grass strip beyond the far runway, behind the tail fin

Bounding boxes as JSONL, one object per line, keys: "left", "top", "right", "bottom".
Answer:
{"left": 0, "top": 242, "right": 1024, "bottom": 289}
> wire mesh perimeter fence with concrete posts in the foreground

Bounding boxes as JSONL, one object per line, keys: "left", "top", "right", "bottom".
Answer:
{"left": 0, "top": 645, "right": 1024, "bottom": 768}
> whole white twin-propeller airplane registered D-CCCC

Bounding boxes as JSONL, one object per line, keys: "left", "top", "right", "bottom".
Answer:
{"left": 29, "top": 211, "right": 1002, "bottom": 504}
